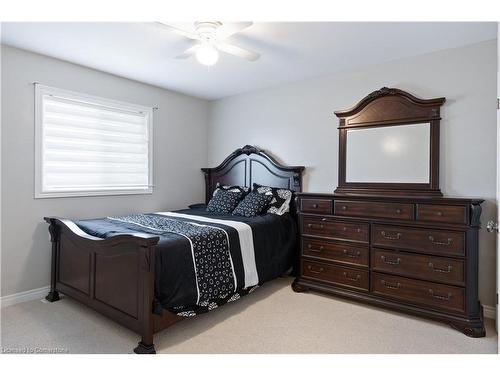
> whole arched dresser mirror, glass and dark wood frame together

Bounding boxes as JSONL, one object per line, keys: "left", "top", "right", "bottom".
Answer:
{"left": 335, "top": 87, "right": 446, "bottom": 198}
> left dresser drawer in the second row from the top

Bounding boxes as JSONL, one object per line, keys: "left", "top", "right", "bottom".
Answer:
{"left": 302, "top": 216, "right": 369, "bottom": 242}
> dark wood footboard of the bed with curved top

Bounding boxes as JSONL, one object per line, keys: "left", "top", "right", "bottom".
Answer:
{"left": 45, "top": 217, "right": 180, "bottom": 353}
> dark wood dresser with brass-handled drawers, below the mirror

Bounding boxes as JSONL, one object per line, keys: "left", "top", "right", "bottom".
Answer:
{"left": 293, "top": 193, "right": 485, "bottom": 337}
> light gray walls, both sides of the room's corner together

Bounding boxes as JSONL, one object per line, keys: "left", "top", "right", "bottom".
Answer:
{"left": 1, "top": 41, "right": 497, "bottom": 306}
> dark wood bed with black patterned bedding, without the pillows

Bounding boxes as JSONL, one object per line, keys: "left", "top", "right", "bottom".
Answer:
{"left": 45, "top": 145, "right": 304, "bottom": 354}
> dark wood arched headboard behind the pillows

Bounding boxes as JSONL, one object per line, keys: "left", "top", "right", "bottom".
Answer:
{"left": 201, "top": 145, "right": 304, "bottom": 203}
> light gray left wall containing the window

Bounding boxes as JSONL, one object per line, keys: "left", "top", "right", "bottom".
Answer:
{"left": 1, "top": 46, "right": 209, "bottom": 296}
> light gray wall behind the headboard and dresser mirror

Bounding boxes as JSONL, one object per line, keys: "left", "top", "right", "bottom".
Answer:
{"left": 208, "top": 40, "right": 497, "bottom": 306}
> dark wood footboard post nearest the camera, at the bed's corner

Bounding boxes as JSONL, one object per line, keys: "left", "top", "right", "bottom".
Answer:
{"left": 134, "top": 245, "right": 156, "bottom": 354}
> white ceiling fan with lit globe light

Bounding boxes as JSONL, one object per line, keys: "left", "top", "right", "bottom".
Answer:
{"left": 156, "top": 21, "right": 260, "bottom": 66}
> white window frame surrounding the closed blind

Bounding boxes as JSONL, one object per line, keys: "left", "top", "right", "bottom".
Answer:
{"left": 34, "top": 83, "right": 154, "bottom": 199}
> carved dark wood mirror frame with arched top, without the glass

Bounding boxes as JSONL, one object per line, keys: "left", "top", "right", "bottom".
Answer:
{"left": 335, "top": 87, "right": 446, "bottom": 197}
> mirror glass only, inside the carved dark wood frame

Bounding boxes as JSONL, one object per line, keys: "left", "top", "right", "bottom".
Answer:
{"left": 345, "top": 123, "right": 431, "bottom": 184}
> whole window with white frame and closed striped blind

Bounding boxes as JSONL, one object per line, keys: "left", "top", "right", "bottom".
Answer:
{"left": 35, "top": 84, "right": 153, "bottom": 198}
